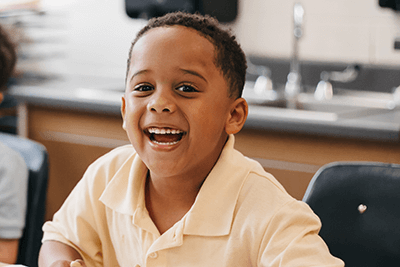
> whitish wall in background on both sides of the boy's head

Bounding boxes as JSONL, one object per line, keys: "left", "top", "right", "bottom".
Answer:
{"left": 32, "top": 0, "right": 400, "bottom": 78}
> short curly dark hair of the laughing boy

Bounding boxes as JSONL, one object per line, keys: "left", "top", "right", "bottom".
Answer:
{"left": 126, "top": 11, "right": 247, "bottom": 98}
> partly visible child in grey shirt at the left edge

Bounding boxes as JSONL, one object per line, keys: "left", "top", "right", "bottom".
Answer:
{"left": 0, "top": 25, "right": 28, "bottom": 263}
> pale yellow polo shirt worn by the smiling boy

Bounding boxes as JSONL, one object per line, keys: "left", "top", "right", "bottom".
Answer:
{"left": 43, "top": 136, "right": 344, "bottom": 267}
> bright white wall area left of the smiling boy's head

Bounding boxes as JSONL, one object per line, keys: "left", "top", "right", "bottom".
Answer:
{"left": 32, "top": 0, "right": 146, "bottom": 79}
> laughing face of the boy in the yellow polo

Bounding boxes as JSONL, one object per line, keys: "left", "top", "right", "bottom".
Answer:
{"left": 122, "top": 26, "right": 235, "bottom": 180}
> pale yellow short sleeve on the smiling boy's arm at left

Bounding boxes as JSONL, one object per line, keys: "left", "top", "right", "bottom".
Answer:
{"left": 42, "top": 161, "right": 104, "bottom": 266}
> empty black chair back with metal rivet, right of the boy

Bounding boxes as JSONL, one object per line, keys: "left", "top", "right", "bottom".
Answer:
{"left": 303, "top": 162, "right": 400, "bottom": 267}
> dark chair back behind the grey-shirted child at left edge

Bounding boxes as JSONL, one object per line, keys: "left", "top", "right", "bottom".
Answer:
{"left": 0, "top": 133, "right": 48, "bottom": 267}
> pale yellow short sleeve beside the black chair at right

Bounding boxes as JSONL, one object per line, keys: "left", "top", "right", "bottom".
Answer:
{"left": 259, "top": 200, "right": 344, "bottom": 267}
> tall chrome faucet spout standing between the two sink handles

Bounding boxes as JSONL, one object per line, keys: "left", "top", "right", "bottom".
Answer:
{"left": 285, "top": 3, "right": 304, "bottom": 109}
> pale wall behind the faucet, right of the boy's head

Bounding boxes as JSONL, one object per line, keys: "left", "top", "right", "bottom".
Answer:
{"left": 234, "top": 0, "right": 400, "bottom": 65}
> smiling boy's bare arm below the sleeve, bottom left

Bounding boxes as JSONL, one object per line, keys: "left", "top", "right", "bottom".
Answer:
{"left": 39, "top": 241, "right": 86, "bottom": 267}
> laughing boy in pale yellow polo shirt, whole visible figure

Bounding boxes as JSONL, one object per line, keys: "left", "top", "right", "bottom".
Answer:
{"left": 39, "top": 13, "right": 343, "bottom": 267}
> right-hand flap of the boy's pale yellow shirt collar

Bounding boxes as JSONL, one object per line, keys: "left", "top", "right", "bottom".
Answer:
{"left": 183, "top": 135, "right": 250, "bottom": 236}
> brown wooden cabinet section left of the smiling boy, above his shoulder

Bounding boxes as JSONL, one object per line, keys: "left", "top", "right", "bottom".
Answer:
{"left": 26, "top": 106, "right": 129, "bottom": 220}
